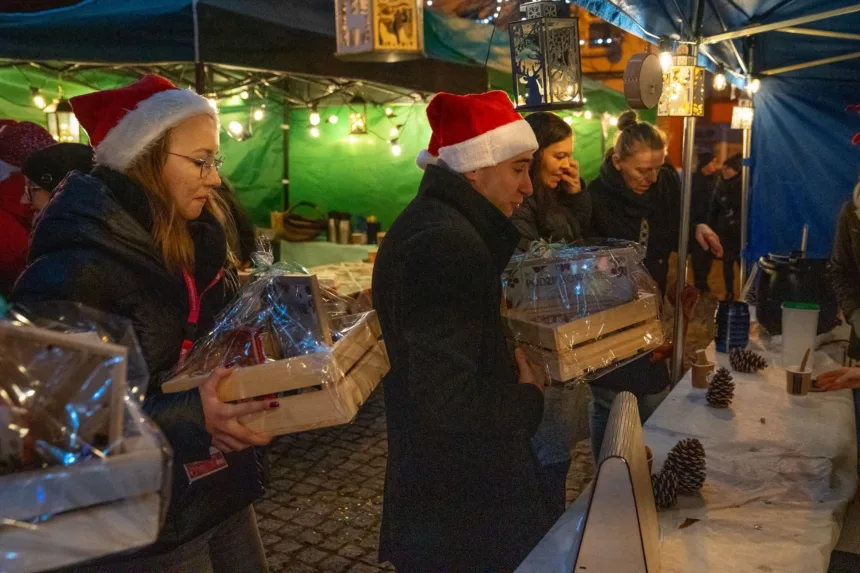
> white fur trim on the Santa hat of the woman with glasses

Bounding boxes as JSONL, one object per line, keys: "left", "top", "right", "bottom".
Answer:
{"left": 95, "top": 90, "right": 218, "bottom": 171}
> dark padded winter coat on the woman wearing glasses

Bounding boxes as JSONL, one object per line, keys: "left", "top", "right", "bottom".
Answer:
{"left": 12, "top": 168, "right": 263, "bottom": 555}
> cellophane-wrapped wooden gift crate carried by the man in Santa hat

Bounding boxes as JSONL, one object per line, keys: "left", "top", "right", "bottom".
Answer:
{"left": 502, "top": 240, "right": 663, "bottom": 382}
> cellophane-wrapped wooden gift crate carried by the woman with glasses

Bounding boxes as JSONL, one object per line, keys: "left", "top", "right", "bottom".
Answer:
{"left": 162, "top": 244, "right": 389, "bottom": 436}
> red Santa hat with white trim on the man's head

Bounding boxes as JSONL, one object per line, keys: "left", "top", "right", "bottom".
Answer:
{"left": 417, "top": 91, "right": 538, "bottom": 173}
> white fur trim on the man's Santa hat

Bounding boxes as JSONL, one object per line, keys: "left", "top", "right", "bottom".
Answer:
{"left": 439, "top": 119, "right": 538, "bottom": 173}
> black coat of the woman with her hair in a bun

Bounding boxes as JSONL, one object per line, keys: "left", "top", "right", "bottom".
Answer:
{"left": 588, "top": 157, "right": 704, "bottom": 294}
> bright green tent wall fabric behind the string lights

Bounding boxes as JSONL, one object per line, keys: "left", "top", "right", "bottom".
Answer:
{"left": 0, "top": 67, "right": 654, "bottom": 228}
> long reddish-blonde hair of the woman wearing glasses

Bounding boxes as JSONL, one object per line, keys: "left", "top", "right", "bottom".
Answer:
{"left": 125, "top": 130, "right": 239, "bottom": 272}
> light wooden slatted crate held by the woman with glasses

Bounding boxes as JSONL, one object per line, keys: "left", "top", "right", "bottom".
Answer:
{"left": 162, "top": 311, "right": 389, "bottom": 435}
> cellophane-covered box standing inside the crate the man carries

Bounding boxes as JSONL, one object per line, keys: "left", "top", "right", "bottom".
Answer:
{"left": 502, "top": 242, "right": 641, "bottom": 316}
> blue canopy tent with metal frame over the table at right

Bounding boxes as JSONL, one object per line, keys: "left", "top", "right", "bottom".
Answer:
{"left": 573, "top": 0, "right": 860, "bottom": 377}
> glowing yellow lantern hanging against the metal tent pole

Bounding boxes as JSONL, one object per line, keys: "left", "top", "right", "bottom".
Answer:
{"left": 657, "top": 44, "right": 705, "bottom": 117}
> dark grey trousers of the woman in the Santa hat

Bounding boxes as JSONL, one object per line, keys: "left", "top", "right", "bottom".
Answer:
{"left": 64, "top": 499, "right": 269, "bottom": 573}
